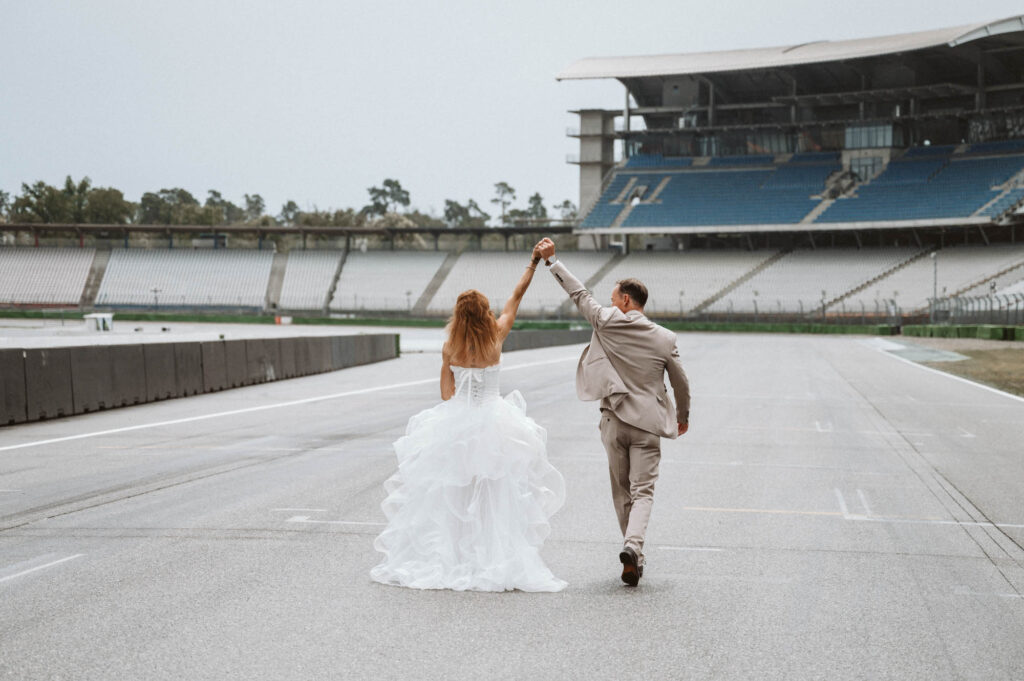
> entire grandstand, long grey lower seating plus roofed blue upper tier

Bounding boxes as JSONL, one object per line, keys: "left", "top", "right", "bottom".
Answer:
{"left": 0, "top": 16, "right": 1024, "bottom": 327}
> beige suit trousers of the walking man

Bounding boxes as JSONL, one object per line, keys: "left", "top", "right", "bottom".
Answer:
{"left": 600, "top": 409, "right": 662, "bottom": 565}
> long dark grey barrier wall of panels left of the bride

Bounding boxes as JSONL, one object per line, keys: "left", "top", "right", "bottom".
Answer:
{"left": 0, "top": 334, "right": 398, "bottom": 427}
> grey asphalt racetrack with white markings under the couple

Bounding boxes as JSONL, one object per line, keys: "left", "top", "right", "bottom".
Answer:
{"left": 0, "top": 330, "right": 1024, "bottom": 681}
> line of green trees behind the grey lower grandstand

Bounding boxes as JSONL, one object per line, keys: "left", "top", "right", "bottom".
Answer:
{"left": 0, "top": 175, "right": 577, "bottom": 227}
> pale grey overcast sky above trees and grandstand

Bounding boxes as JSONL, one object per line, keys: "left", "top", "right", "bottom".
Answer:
{"left": 0, "top": 0, "right": 1022, "bottom": 219}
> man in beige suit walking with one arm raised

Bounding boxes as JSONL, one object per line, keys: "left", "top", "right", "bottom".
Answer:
{"left": 535, "top": 238, "right": 690, "bottom": 587}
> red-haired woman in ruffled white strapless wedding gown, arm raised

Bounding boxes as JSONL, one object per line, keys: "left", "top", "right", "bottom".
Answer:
{"left": 370, "top": 242, "right": 565, "bottom": 591}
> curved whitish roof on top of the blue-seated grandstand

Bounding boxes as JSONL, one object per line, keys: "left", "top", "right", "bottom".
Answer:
{"left": 556, "top": 15, "right": 1024, "bottom": 80}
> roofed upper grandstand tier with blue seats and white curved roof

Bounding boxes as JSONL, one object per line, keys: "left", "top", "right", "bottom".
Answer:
{"left": 559, "top": 16, "right": 1024, "bottom": 238}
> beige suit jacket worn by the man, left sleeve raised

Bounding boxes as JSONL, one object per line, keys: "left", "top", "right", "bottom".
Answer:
{"left": 551, "top": 261, "right": 690, "bottom": 438}
